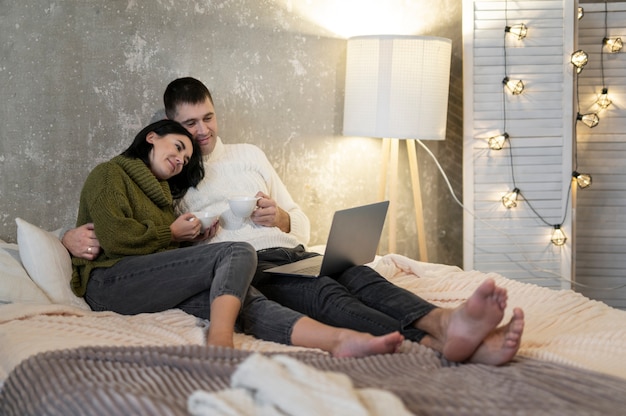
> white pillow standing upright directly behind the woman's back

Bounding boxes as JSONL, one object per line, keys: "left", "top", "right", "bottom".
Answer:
{"left": 15, "top": 218, "right": 90, "bottom": 310}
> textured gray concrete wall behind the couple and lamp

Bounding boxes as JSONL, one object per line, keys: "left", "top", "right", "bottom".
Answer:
{"left": 0, "top": 0, "right": 462, "bottom": 264}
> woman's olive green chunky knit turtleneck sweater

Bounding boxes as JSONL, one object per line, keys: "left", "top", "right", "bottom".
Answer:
{"left": 71, "top": 156, "right": 179, "bottom": 296}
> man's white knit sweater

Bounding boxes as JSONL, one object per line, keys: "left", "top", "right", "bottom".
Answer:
{"left": 177, "top": 137, "right": 311, "bottom": 250}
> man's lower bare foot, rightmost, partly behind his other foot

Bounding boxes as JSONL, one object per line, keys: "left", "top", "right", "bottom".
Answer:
{"left": 468, "top": 308, "right": 524, "bottom": 365}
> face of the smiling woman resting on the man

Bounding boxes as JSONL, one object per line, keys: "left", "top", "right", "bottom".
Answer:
{"left": 146, "top": 132, "right": 193, "bottom": 180}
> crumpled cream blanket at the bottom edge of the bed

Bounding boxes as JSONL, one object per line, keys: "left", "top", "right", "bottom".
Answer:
{"left": 187, "top": 354, "right": 411, "bottom": 416}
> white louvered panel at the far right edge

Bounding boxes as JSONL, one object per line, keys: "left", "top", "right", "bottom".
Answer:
{"left": 575, "top": 2, "right": 626, "bottom": 309}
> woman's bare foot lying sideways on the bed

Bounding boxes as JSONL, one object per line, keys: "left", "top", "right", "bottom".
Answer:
{"left": 330, "top": 330, "right": 404, "bottom": 357}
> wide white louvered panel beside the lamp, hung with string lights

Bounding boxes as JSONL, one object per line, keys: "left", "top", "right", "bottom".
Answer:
{"left": 463, "top": 0, "right": 575, "bottom": 288}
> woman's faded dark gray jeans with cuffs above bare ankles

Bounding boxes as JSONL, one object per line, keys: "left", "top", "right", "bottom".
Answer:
{"left": 85, "top": 242, "right": 303, "bottom": 344}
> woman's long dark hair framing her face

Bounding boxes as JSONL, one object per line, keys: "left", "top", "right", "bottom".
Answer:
{"left": 122, "top": 120, "right": 204, "bottom": 199}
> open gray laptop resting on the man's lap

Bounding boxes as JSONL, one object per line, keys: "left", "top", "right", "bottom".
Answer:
{"left": 265, "top": 201, "right": 389, "bottom": 278}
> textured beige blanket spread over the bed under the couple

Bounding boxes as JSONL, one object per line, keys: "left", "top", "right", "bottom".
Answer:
{"left": 0, "top": 254, "right": 626, "bottom": 382}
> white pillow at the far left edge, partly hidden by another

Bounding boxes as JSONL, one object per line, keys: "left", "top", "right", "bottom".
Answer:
{"left": 0, "top": 242, "right": 51, "bottom": 304}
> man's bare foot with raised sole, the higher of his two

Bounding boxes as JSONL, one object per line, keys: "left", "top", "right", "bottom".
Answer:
{"left": 441, "top": 279, "right": 507, "bottom": 362}
